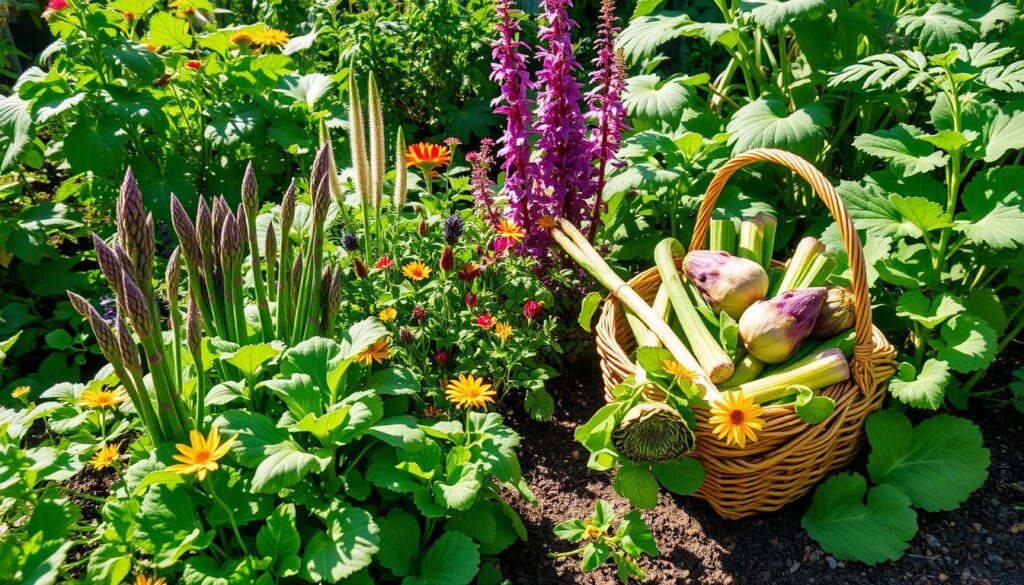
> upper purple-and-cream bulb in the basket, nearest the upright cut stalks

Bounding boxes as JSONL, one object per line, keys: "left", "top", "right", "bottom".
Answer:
{"left": 683, "top": 250, "right": 768, "bottom": 319}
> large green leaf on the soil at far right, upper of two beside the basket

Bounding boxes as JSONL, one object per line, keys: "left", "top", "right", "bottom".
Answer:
{"left": 866, "top": 410, "right": 989, "bottom": 512}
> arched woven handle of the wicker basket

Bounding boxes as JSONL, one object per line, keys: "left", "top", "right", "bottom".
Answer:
{"left": 690, "top": 149, "right": 874, "bottom": 392}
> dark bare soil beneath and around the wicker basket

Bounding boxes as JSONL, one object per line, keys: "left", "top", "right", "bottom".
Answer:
{"left": 501, "top": 364, "right": 1024, "bottom": 585}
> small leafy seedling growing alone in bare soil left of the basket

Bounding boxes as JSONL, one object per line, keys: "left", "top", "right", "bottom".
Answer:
{"left": 548, "top": 500, "right": 662, "bottom": 583}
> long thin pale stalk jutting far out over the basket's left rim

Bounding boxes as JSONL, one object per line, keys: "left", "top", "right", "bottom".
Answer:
{"left": 551, "top": 219, "right": 721, "bottom": 401}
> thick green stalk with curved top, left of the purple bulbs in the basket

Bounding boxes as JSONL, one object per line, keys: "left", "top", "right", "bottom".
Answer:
{"left": 654, "top": 238, "right": 733, "bottom": 382}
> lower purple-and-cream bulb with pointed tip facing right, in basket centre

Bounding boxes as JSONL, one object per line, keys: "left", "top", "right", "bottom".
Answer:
{"left": 739, "top": 287, "right": 825, "bottom": 364}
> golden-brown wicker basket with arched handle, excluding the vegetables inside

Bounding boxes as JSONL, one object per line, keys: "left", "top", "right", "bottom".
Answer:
{"left": 597, "top": 149, "right": 896, "bottom": 519}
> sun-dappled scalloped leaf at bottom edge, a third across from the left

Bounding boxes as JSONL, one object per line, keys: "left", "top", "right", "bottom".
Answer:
{"left": 302, "top": 504, "right": 381, "bottom": 583}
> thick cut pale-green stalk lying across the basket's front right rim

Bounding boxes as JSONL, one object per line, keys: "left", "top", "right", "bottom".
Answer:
{"left": 722, "top": 347, "right": 850, "bottom": 404}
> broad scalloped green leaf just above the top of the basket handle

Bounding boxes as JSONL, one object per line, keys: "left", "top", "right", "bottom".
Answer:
{"left": 726, "top": 95, "right": 831, "bottom": 158}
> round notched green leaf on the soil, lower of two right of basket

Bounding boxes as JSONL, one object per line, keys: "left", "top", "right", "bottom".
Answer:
{"left": 800, "top": 473, "right": 918, "bottom": 565}
